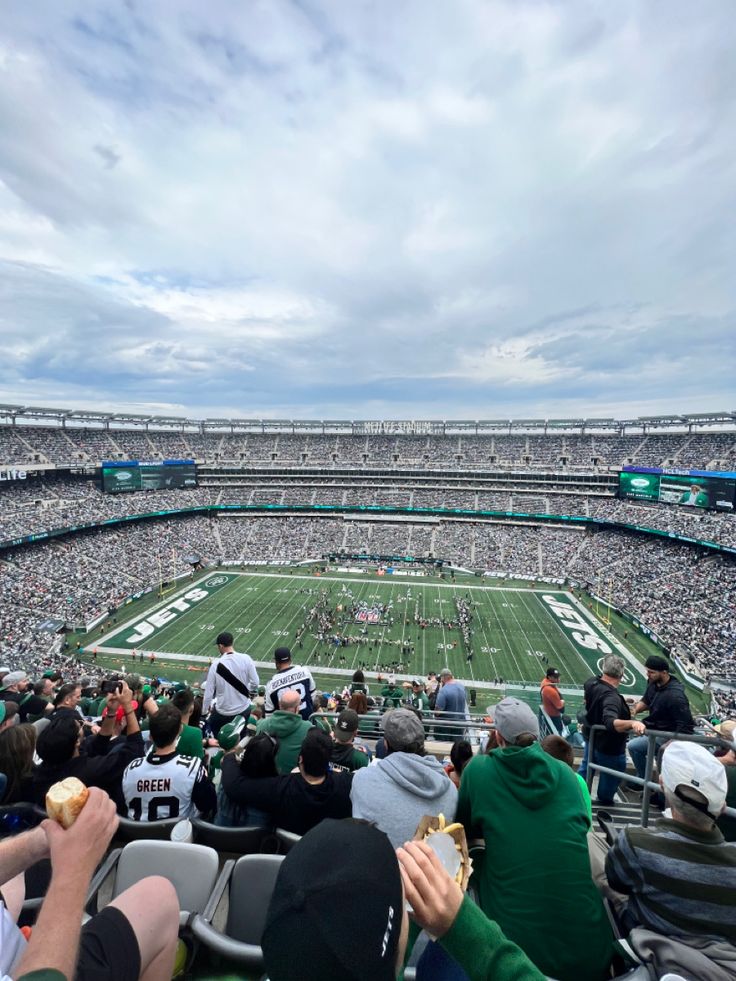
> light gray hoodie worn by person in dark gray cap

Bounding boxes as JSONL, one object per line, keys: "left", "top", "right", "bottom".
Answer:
{"left": 350, "top": 753, "right": 457, "bottom": 848}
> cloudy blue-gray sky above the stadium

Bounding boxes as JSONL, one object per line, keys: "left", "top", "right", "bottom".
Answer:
{"left": 0, "top": 0, "right": 736, "bottom": 419}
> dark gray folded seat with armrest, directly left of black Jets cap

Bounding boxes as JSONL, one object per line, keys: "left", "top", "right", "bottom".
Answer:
{"left": 189, "top": 846, "right": 283, "bottom": 973}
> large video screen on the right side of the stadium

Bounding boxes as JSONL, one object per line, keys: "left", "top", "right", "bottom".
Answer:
{"left": 618, "top": 467, "right": 736, "bottom": 511}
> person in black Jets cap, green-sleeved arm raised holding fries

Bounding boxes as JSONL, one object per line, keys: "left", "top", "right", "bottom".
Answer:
{"left": 262, "top": 821, "right": 543, "bottom": 981}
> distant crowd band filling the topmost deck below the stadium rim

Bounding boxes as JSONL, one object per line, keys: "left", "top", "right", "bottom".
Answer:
{"left": 0, "top": 425, "right": 736, "bottom": 470}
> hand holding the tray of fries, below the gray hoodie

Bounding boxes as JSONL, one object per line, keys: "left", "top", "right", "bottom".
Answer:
{"left": 396, "top": 841, "right": 463, "bottom": 937}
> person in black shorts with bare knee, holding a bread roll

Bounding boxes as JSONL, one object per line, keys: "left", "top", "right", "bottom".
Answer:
{"left": 0, "top": 788, "right": 179, "bottom": 981}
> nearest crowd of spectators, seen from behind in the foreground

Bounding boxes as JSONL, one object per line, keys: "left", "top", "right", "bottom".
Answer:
{"left": 0, "top": 644, "right": 736, "bottom": 981}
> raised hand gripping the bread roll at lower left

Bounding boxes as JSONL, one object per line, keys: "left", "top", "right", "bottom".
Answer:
{"left": 41, "top": 787, "right": 118, "bottom": 879}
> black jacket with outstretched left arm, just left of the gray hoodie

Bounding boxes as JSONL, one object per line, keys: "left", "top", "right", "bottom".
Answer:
{"left": 222, "top": 753, "right": 352, "bottom": 835}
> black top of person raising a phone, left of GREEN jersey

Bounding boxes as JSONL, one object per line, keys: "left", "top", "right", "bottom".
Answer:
{"left": 33, "top": 732, "right": 143, "bottom": 816}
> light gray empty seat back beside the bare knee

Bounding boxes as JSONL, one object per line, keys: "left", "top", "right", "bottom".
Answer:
{"left": 112, "top": 840, "right": 220, "bottom": 925}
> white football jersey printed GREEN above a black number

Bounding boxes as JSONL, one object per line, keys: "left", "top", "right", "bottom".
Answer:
{"left": 123, "top": 750, "right": 207, "bottom": 821}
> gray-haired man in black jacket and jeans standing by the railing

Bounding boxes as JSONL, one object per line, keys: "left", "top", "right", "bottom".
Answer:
{"left": 583, "top": 654, "right": 644, "bottom": 807}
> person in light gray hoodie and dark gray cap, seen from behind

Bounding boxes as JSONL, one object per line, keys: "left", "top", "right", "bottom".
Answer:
{"left": 351, "top": 709, "right": 457, "bottom": 848}
